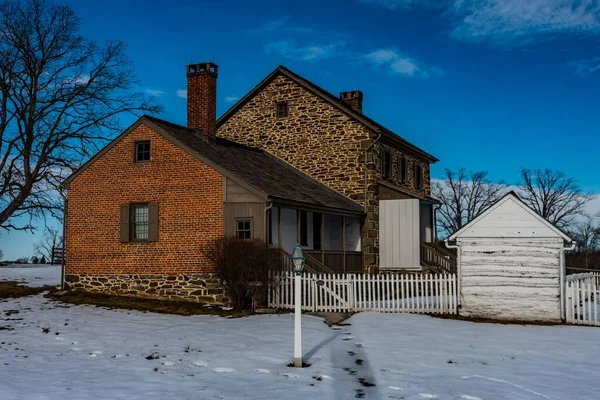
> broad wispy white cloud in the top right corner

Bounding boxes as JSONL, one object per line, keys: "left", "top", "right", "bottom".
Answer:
{"left": 358, "top": 0, "right": 600, "bottom": 44}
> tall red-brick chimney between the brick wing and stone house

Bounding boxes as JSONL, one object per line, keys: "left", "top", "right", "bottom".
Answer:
{"left": 186, "top": 62, "right": 219, "bottom": 137}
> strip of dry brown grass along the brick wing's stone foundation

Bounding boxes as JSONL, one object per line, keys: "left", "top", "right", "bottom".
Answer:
{"left": 46, "top": 290, "right": 253, "bottom": 318}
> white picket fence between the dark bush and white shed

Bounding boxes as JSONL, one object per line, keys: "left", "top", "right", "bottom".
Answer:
{"left": 268, "top": 272, "right": 458, "bottom": 314}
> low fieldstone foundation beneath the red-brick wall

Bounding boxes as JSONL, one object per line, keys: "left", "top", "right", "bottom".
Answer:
{"left": 65, "top": 274, "right": 227, "bottom": 304}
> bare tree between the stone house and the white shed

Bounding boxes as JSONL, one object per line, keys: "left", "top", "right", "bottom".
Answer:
{"left": 431, "top": 168, "right": 507, "bottom": 235}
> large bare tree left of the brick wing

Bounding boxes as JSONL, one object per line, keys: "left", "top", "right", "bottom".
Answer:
{"left": 0, "top": 0, "right": 160, "bottom": 230}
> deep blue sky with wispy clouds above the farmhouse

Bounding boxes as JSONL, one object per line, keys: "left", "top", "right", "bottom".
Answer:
{"left": 0, "top": 0, "right": 600, "bottom": 258}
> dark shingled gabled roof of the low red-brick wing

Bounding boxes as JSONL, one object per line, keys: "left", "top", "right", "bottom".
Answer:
{"left": 63, "top": 116, "right": 363, "bottom": 214}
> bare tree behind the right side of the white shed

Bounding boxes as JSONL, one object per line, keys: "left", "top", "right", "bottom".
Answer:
{"left": 519, "top": 168, "right": 592, "bottom": 228}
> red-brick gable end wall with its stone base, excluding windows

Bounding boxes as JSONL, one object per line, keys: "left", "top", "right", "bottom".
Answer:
{"left": 65, "top": 125, "right": 223, "bottom": 302}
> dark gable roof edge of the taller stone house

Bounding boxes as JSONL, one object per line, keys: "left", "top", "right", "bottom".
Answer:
{"left": 217, "top": 65, "right": 439, "bottom": 163}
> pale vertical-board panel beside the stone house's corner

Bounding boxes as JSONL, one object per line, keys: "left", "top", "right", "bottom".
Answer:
{"left": 379, "top": 199, "right": 421, "bottom": 269}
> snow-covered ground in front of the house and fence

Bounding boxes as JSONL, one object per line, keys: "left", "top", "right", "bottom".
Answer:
{"left": 0, "top": 268, "right": 600, "bottom": 400}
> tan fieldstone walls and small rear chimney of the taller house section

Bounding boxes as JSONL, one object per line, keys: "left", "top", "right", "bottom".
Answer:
{"left": 217, "top": 75, "right": 429, "bottom": 271}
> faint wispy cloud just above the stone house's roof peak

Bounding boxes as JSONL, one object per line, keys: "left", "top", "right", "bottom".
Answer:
{"left": 265, "top": 40, "right": 346, "bottom": 62}
